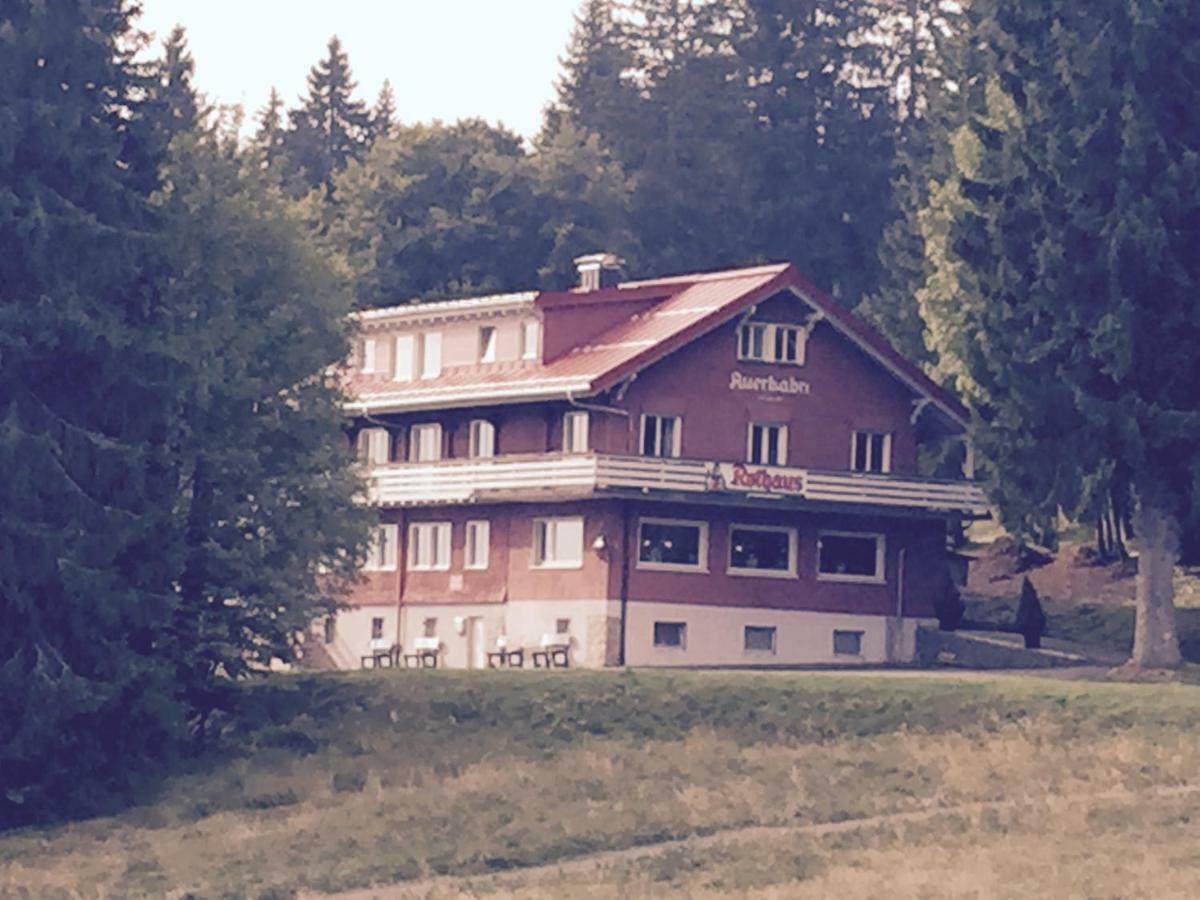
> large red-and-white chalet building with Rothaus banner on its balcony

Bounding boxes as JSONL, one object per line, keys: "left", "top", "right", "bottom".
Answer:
{"left": 312, "top": 254, "right": 984, "bottom": 668}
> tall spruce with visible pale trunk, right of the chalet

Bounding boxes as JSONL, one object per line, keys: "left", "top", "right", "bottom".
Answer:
{"left": 920, "top": 0, "right": 1200, "bottom": 666}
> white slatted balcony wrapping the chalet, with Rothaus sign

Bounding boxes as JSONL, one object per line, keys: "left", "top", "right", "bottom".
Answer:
{"left": 371, "top": 454, "right": 988, "bottom": 516}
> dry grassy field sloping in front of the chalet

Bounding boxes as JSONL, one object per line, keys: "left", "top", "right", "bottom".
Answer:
{"left": 0, "top": 670, "right": 1200, "bottom": 899}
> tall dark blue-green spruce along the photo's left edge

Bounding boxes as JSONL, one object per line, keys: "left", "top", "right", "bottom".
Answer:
{"left": 0, "top": 0, "right": 182, "bottom": 824}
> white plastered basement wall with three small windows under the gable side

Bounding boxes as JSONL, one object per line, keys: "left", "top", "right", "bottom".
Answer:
{"left": 625, "top": 602, "right": 923, "bottom": 666}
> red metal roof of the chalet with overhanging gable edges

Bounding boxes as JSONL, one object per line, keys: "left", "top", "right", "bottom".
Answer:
{"left": 347, "top": 263, "right": 967, "bottom": 422}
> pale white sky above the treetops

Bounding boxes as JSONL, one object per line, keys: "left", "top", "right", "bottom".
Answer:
{"left": 139, "top": 0, "right": 582, "bottom": 137}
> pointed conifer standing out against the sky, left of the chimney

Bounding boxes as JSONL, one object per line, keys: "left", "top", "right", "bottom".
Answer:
{"left": 284, "top": 35, "right": 371, "bottom": 197}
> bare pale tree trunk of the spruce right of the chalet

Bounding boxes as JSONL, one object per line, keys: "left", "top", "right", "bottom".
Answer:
{"left": 1129, "top": 499, "right": 1181, "bottom": 668}
